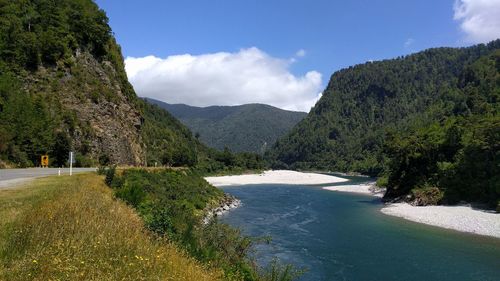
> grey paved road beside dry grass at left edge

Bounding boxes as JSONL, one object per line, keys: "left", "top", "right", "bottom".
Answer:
{"left": 0, "top": 168, "right": 95, "bottom": 189}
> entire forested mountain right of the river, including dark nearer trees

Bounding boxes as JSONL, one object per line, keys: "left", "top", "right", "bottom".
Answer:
{"left": 268, "top": 40, "right": 500, "bottom": 204}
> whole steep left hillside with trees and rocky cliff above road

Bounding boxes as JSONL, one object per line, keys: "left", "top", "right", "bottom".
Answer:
{"left": 0, "top": 0, "right": 263, "bottom": 172}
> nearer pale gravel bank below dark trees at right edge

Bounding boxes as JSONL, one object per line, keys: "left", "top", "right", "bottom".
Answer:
{"left": 382, "top": 203, "right": 500, "bottom": 238}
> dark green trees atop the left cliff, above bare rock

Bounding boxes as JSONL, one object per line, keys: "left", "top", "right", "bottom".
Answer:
{"left": 0, "top": 0, "right": 111, "bottom": 69}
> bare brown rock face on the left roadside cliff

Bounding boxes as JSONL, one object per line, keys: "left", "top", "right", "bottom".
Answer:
{"left": 25, "top": 52, "right": 144, "bottom": 165}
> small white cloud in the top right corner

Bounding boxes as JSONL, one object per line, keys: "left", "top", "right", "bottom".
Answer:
{"left": 453, "top": 0, "right": 500, "bottom": 43}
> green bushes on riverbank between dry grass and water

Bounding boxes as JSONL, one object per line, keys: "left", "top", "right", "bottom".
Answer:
{"left": 107, "top": 169, "right": 253, "bottom": 280}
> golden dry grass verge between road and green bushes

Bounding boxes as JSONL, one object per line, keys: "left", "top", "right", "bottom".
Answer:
{"left": 0, "top": 174, "right": 222, "bottom": 281}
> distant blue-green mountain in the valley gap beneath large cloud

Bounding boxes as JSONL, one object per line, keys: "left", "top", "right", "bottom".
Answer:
{"left": 146, "top": 98, "right": 306, "bottom": 153}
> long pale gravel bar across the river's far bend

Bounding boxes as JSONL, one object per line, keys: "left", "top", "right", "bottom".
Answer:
{"left": 205, "top": 170, "right": 348, "bottom": 186}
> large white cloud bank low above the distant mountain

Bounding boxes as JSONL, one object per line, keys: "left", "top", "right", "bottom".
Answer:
{"left": 125, "top": 48, "right": 322, "bottom": 111}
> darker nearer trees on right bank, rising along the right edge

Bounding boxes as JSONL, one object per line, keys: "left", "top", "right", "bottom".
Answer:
{"left": 385, "top": 47, "right": 500, "bottom": 208}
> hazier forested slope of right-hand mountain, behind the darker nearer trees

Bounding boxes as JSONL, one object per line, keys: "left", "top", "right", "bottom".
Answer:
{"left": 267, "top": 40, "right": 500, "bottom": 176}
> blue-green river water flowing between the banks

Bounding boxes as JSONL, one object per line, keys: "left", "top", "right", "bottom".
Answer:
{"left": 222, "top": 178, "right": 500, "bottom": 281}
